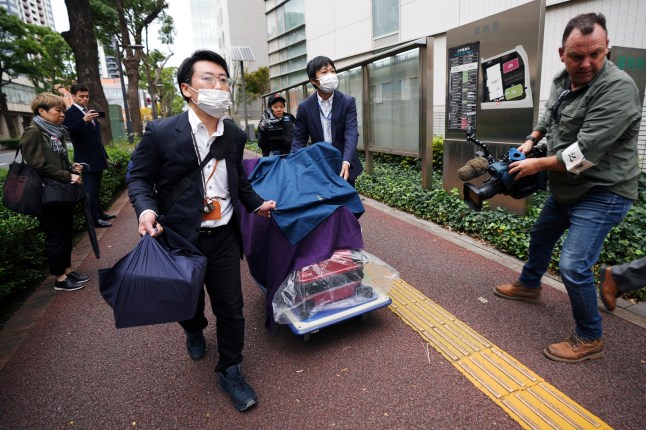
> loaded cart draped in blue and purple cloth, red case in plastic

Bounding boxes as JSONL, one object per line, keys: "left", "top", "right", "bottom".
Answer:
{"left": 240, "top": 144, "right": 396, "bottom": 337}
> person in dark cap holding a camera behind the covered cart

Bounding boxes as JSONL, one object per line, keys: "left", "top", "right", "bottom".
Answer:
{"left": 258, "top": 93, "right": 295, "bottom": 157}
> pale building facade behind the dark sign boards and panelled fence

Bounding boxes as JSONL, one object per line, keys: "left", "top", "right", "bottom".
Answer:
{"left": 265, "top": 0, "right": 646, "bottom": 171}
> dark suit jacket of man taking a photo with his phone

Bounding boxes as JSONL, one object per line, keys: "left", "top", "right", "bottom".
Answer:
{"left": 64, "top": 105, "right": 108, "bottom": 172}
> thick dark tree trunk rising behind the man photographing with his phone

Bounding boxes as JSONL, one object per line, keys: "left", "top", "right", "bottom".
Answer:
{"left": 61, "top": 0, "right": 112, "bottom": 145}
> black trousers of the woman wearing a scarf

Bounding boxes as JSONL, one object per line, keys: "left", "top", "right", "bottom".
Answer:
{"left": 38, "top": 205, "right": 74, "bottom": 276}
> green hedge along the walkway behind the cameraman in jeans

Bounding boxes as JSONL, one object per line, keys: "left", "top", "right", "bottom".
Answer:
{"left": 356, "top": 149, "right": 646, "bottom": 300}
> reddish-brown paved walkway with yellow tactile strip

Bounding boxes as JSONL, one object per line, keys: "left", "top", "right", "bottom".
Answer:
{"left": 0, "top": 190, "right": 646, "bottom": 429}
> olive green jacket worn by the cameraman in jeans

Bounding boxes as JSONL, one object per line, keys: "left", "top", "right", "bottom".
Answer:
{"left": 534, "top": 60, "right": 641, "bottom": 203}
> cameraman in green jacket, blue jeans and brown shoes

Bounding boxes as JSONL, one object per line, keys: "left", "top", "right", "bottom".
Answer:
{"left": 494, "top": 13, "right": 641, "bottom": 363}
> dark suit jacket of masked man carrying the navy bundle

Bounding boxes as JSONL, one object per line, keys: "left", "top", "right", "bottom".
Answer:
{"left": 128, "top": 112, "right": 263, "bottom": 252}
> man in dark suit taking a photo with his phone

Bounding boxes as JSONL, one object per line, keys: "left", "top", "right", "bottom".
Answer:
{"left": 64, "top": 84, "right": 115, "bottom": 228}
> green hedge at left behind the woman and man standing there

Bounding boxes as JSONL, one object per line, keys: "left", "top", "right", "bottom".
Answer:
{"left": 0, "top": 143, "right": 132, "bottom": 301}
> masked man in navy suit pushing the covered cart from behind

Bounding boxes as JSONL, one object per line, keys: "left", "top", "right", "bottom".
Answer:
{"left": 292, "top": 56, "right": 363, "bottom": 186}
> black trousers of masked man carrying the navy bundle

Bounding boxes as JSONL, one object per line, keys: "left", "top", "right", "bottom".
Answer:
{"left": 179, "top": 225, "right": 245, "bottom": 372}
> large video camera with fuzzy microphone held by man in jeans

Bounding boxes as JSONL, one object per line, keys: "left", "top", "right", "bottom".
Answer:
{"left": 458, "top": 127, "right": 547, "bottom": 211}
